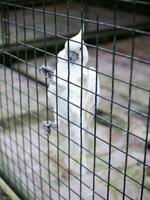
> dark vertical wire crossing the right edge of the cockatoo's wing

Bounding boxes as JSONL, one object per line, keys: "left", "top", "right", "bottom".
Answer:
{"left": 92, "top": 15, "right": 100, "bottom": 200}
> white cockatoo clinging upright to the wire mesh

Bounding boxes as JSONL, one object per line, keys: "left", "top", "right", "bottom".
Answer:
{"left": 39, "top": 27, "right": 100, "bottom": 175}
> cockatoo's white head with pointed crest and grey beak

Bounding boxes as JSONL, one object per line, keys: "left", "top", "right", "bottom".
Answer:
{"left": 65, "top": 30, "right": 88, "bottom": 66}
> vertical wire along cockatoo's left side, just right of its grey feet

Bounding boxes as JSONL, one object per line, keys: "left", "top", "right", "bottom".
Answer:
{"left": 54, "top": 2, "right": 61, "bottom": 199}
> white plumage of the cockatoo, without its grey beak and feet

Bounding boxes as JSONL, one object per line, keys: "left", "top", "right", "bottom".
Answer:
{"left": 48, "top": 31, "right": 100, "bottom": 173}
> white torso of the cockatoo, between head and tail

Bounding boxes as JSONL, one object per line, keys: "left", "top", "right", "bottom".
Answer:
{"left": 49, "top": 62, "right": 99, "bottom": 128}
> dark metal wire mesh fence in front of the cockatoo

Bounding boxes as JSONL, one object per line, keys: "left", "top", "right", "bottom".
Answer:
{"left": 0, "top": 1, "right": 150, "bottom": 200}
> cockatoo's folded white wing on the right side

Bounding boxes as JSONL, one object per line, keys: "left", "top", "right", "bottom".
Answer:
{"left": 82, "top": 67, "right": 100, "bottom": 122}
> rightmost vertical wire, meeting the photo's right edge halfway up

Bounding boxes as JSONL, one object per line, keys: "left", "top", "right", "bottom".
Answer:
{"left": 140, "top": 92, "right": 150, "bottom": 200}
